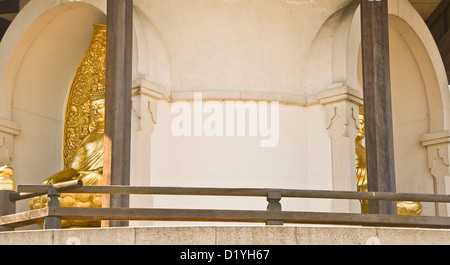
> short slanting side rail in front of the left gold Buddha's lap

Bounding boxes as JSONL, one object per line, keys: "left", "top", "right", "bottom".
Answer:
{"left": 9, "top": 179, "right": 83, "bottom": 201}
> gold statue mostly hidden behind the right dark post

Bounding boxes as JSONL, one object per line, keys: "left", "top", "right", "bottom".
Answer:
{"left": 355, "top": 106, "right": 422, "bottom": 216}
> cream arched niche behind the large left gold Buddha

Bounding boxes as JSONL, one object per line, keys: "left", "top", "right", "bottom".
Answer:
{"left": 0, "top": 0, "right": 106, "bottom": 196}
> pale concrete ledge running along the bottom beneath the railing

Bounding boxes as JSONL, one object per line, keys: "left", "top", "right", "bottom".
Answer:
{"left": 0, "top": 226, "right": 450, "bottom": 245}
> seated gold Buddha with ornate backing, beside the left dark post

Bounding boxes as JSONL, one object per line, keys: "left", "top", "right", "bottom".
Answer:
{"left": 29, "top": 24, "right": 106, "bottom": 228}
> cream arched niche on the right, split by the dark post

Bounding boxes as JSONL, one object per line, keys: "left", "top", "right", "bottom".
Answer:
{"left": 305, "top": 0, "right": 450, "bottom": 215}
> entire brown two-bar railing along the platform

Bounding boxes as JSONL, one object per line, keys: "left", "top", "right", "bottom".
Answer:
{"left": 0, "top": 180, "right": 450, "bottom": 231}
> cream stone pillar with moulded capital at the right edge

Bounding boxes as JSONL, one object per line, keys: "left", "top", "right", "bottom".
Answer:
{"left": 421, "top": 130, "right": 450, "bottom": 216}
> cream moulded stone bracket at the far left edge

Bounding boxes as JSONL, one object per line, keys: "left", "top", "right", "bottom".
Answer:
{"left": 0, "top": 119, "right": 20, "bottom": 165}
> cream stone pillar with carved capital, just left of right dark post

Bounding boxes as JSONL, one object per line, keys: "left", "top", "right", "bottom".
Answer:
{"left": 317, "top": 84, "right": 363, "bottom": 213}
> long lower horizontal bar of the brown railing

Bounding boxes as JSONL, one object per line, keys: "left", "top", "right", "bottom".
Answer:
{"left": 44, "top": 208, "right": 450, "bottom": 228}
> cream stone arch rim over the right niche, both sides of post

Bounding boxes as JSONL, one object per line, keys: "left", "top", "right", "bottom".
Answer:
{"left": 305, "top": 0, "right": 450, "bottom": 133}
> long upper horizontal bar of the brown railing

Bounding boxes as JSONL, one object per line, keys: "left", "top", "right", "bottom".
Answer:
{"left": 14, "top": 185, "right": 450, "bottom": 203}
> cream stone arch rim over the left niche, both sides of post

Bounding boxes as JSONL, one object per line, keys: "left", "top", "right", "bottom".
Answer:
{"left": 0, "top": 0, "right": 170, "bottom": 120}
